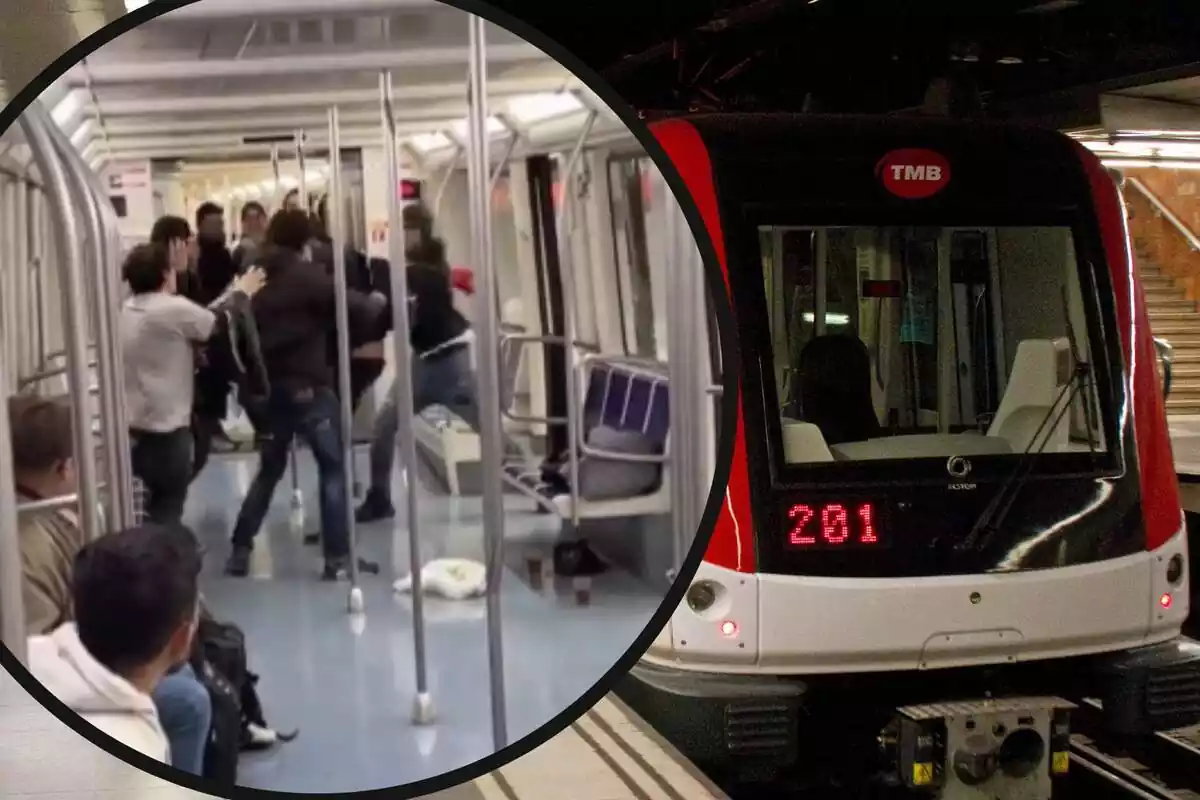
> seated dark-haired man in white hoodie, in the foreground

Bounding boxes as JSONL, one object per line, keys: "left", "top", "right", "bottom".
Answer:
{"left": 29, "top": 524, "right": 200, "bottom": 764}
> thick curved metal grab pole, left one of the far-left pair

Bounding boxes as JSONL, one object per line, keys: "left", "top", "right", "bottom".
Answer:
{"left": 18, "top": 113, "right": 101, "bottom": 540}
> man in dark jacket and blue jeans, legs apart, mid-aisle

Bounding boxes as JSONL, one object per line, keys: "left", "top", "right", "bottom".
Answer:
{"left": 226, "top": 211, "right": 385, "bottom": 581}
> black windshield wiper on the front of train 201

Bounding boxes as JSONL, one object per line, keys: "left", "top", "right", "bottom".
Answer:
{"left": 955, "top": 287, "right": 1096, "bottom": 549}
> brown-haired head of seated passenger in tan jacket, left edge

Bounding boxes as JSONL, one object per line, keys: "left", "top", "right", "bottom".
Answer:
{"left": 8, "top": 395, "right": 76, "bottom": 497}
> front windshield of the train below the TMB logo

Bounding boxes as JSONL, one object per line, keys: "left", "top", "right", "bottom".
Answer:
{"left": 758, "top": 227, "right": 1104, "bottom": 463}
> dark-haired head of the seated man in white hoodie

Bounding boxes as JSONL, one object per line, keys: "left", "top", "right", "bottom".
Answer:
{"left": 71, "top": 524, "right": 200, "bottom": 691}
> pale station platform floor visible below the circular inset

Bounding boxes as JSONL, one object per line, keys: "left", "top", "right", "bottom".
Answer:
{"left": 0, "top": 669, "right": 728, "bottom": 800}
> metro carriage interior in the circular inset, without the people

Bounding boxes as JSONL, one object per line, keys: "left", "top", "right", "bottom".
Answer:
{"left": 0, "top": 1, "right": 721, "bottom": 793}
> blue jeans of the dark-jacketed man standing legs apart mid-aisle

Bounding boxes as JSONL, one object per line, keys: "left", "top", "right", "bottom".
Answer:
{"left": 233, "top": 386, "right": 350, "bottom": 559}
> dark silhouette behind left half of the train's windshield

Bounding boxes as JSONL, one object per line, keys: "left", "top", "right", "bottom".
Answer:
{"left": 797, "top": 335, "right": 881, "bottom": 445}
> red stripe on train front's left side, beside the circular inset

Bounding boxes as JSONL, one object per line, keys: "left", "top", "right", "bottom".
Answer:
{"left": 650, "top": 120, "right": 755, "bottom": 572}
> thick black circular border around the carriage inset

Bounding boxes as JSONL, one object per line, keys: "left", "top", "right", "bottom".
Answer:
{"left": 0, "top": 0, "right": 740, "bottom": 799}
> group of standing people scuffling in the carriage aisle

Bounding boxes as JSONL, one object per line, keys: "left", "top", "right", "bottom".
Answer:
{"left": 120, "top": 199, "right": 492, "bottom": 579}
